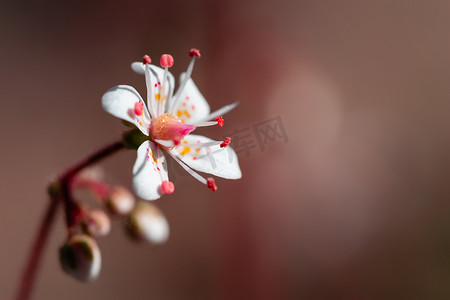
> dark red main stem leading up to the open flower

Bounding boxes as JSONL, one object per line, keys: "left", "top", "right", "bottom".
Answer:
{"left": 15, "top": 141, "right": 125, "bottom": 300}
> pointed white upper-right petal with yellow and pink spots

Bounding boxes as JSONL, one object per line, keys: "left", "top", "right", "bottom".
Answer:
{"left": 171, "top": 73, "right": 210, "bottom": 124}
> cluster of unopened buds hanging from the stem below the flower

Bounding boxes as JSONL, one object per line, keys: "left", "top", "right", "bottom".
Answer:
{"left": 60, "top": 170, "right": 169, "bottom": 281}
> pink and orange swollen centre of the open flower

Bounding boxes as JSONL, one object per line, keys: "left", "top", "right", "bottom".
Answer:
{"left": 150, "top": 113, "right": 196, "bottom": 144}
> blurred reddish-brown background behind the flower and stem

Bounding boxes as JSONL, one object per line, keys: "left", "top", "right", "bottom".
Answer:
{"left": 0, "top": 0, "right": 450, "bottom": 300}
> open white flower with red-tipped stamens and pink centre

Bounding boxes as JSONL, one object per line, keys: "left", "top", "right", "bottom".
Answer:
{"left": 102, "top": 49, "right": 242, "bottom": 200}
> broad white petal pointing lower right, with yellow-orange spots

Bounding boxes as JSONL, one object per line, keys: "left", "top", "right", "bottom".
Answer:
{"left": 173, "top": 134, "right": 242, "bottom": 179}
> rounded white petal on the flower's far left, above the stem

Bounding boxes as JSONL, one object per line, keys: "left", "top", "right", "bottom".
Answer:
{"left": 102, "top": 85, "right": 150, "bottom": 135}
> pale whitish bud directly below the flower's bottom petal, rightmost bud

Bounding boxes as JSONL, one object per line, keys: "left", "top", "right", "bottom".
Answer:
{"left": 125, "top": 202, "right": 169, "bottom": 244}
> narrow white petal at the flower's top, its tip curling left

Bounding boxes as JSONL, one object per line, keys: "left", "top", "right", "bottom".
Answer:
{"left": 131, "top": 62, "right": 175, "bottom": 112}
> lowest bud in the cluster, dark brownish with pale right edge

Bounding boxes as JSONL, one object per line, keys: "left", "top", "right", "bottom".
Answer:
{"left": 59, "top": 234, "right": 102, "bottom": 282}
